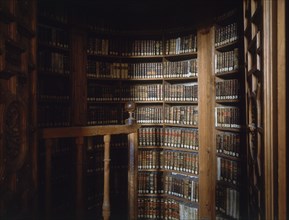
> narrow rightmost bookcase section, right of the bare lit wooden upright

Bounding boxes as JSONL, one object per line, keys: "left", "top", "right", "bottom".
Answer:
{"left": 215, "top": 10, "right": 246, "bottom": 219}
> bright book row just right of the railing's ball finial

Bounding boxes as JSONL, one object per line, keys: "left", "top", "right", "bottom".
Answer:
{"left": 136, "top": 105, "right": 198, "bottom": 125}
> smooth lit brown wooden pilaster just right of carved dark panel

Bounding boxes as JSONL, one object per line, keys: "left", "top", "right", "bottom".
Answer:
{"left": 263, "top": 0, "right": 278, "bottom": 219}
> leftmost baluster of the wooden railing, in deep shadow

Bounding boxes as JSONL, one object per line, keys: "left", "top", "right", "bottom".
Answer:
{"left": 45, "top": 139, "right": 53, "bottom": 220}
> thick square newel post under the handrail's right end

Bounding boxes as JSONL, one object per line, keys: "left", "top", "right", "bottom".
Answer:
{"left": 128, "top": 133, "right": 138, "bottom": 220}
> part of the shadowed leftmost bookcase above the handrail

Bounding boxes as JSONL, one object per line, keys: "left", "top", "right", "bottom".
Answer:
{"left": 37, "top": 5, "right": 72, "bottom": 127}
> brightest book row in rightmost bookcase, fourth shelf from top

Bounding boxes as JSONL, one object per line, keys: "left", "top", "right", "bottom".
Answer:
{"left": 215, "top": 106, "right": 241, "bottom": 128}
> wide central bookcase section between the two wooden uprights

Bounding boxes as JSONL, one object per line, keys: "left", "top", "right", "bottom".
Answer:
{"left": 83, "top": 28, "right": 199, "bottom": 218}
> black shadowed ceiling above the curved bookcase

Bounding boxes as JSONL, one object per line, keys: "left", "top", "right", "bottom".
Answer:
{"left": 39, "top": 0, "right": 242, "bottom": 29}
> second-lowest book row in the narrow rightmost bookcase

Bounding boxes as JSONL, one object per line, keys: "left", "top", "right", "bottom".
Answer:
{"left": 217, "top": 157, "right": 240, "bottom": 185}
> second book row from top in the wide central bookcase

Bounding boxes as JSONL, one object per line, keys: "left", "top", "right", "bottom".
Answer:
{"left": 86, "top": 59, "right": 198, "bottom": 79}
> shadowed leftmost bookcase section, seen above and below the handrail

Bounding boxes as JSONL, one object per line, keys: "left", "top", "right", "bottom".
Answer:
{"left": 37, "top": 2, "right": 76, "bottom": 218}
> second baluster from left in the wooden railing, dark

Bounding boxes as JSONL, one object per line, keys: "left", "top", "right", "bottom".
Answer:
{"left": 75, "top": 137, "right": 84, "bottom": 219}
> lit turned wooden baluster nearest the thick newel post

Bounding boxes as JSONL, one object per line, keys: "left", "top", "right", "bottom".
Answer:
{"left": 102, "top": 135, "right": 110, "bottom": 220}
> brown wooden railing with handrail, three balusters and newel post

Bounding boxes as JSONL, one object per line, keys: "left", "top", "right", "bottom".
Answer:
{"left": 40, "top": 124, "right": 140, "bottom": 220}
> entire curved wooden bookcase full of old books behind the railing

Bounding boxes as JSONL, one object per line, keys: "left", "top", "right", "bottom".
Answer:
{"left": 35, "top": 0, "right": 245, "bottom": 219}
